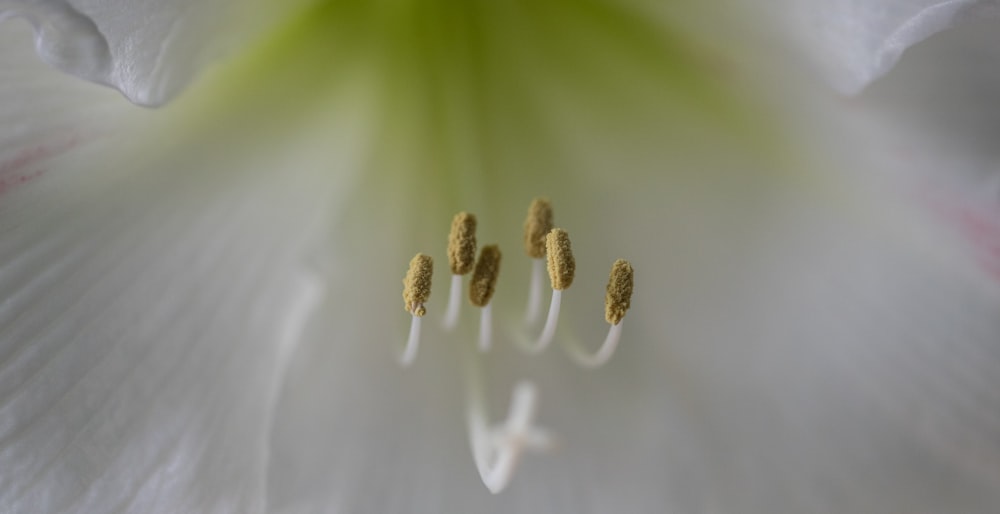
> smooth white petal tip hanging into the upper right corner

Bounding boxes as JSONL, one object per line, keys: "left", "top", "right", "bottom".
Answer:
{"left": 786, "top": 0, "right": 1000, "bottom": 94}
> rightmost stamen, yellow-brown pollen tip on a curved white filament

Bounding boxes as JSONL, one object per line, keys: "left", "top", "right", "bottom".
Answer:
{"left": 564, "top": 259, "right": 633, "bottom": 368}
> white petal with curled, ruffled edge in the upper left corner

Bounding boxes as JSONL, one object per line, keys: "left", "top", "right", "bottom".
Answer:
{"left": 0, "top": 0, "right": 303, "bottom": 105}
